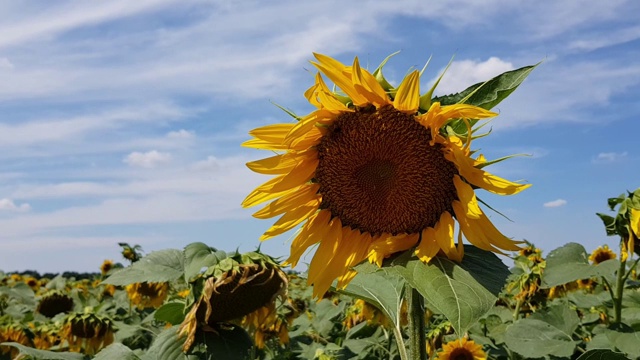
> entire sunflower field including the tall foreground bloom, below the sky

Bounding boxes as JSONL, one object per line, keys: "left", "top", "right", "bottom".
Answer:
{"left": 0, "top": 54, "right": 640, "bottom": 360}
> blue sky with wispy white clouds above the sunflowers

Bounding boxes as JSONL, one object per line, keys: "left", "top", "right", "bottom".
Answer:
{"left": 0, "top": 0, "right": 640, "bottom": 272}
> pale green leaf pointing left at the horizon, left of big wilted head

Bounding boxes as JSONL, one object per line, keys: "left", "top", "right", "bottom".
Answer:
{"left": 103, "top": 249, "right": 184, "bottom": 286}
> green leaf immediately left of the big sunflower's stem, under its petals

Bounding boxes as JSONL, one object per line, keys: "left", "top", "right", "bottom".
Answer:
{"left": 339, "top": 262, "right": 405, "bottom": 327}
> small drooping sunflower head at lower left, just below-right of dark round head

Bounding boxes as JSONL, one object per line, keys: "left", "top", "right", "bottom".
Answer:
{"left": 61, "top": 311, "right": 115, "bottom": 355}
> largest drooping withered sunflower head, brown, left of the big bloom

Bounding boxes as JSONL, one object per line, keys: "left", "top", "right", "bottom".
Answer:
{"left": 179, "top": 252, "right": 289, "bottom": 352}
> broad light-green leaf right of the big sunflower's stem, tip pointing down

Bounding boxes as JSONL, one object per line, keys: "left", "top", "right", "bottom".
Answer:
{"left": 391, "top": 252, "right": 497, "bottom": 334}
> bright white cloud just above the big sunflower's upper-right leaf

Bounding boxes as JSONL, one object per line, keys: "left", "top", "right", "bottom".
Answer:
{"left": 430, "top": 57, "right": 514, "bottom": 95}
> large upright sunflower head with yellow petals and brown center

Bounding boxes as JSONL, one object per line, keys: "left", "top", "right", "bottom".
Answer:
{"left": 242, "top": 54, "right": 529, "bottom": 296}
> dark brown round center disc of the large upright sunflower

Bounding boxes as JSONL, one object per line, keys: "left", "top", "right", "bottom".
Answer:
{"left": 315, "top": 106, "right": 458, "bottom": 234}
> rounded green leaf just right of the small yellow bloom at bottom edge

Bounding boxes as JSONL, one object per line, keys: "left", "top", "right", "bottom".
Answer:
{"left": 505, "top": 318, "right": 576, "bottom": 358}
